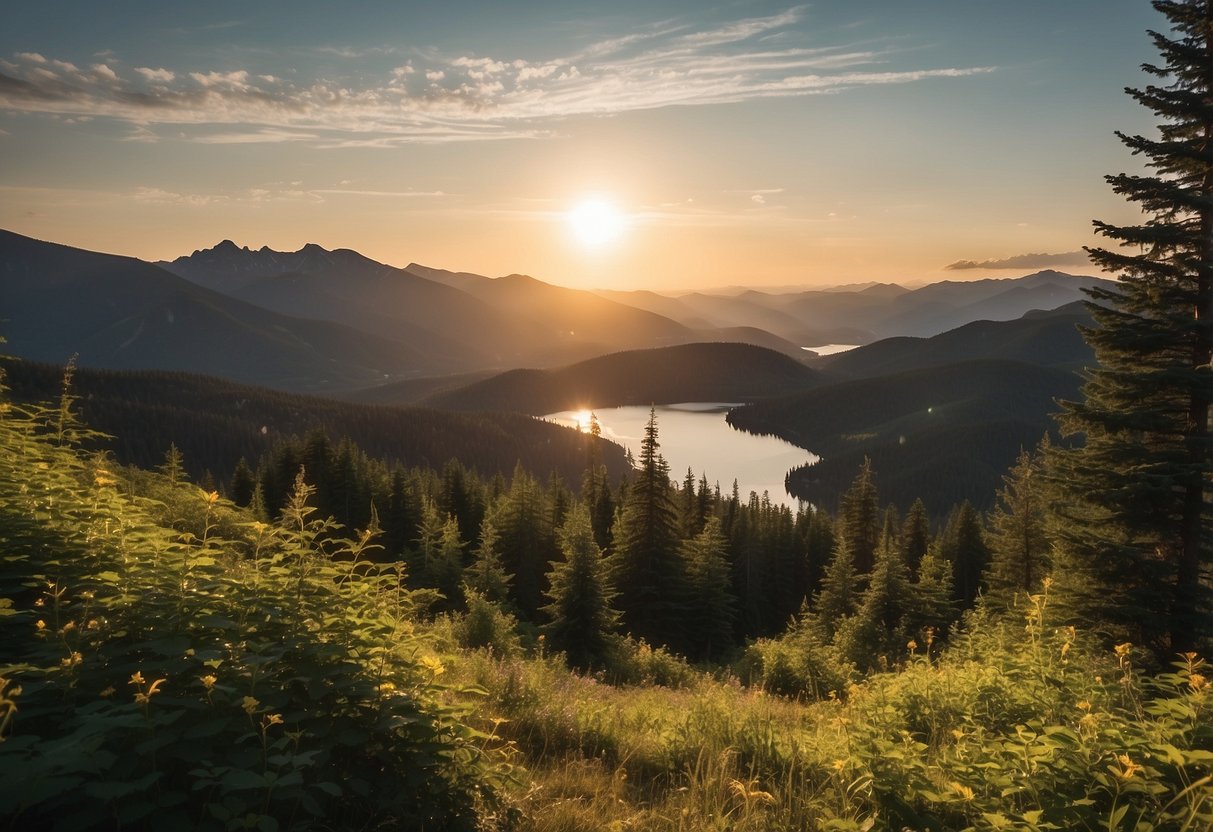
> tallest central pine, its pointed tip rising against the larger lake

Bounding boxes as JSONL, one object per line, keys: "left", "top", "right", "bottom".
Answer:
{"left": 613, "top": 410, "right": 687, "bottom": 645}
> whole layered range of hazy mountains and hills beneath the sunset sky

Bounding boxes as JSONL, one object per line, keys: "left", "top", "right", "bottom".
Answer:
{"left": 0, "top": 232, "right": 1115, "bottom": 511}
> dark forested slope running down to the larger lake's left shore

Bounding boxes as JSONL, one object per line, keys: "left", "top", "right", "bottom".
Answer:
{"left": 0, "top": 358, "right": 626, "bottom": 483}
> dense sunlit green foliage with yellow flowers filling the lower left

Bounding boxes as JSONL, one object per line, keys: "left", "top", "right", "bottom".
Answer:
{"left": 0, "top": 395, "right": 508, "bottom": 830}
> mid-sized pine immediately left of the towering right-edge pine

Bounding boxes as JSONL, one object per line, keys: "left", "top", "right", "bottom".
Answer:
{"left": 985, "top": 446, "right": 1050, "bottom": 611}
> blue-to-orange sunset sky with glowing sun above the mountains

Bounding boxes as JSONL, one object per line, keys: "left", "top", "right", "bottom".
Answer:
{"left": 0, "top": 0, "right": 1163, "bottom": 291}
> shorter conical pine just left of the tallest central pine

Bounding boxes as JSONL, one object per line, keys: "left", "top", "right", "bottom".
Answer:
{"left": 542, "top": 503, "right": 619, "bottom": 671}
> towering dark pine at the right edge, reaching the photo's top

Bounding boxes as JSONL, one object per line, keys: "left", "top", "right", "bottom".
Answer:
{"left": 1055, "top": 0, "right": 1213, "bottom": 654}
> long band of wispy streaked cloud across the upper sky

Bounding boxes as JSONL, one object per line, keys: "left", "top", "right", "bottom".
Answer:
{"left": 0, "top": 7, "right": 992, "bottom": 148}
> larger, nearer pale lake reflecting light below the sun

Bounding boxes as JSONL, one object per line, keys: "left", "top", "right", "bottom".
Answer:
{"left": 543, "top": 401, "right": 818, "bottom": 511}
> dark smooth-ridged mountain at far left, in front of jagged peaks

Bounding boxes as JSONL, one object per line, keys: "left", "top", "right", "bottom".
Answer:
{"left": 0, "top": 232, "right": 427, "bottom": 391}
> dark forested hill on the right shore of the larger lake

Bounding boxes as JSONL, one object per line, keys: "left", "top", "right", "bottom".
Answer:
{"left": 728, "top": 360, "right": 1081, "bottom": 517}
